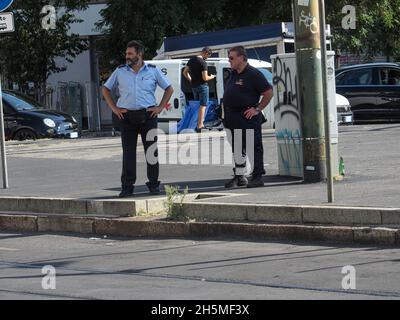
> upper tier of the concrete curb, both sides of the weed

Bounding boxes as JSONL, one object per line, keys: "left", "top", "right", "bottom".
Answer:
{"left": 0, "top": 194, "right": 400, "bottom": 227}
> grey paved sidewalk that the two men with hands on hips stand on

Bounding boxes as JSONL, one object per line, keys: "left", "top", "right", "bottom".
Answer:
{"left": 0, "top": 124, "right": 400, "bottom": 208}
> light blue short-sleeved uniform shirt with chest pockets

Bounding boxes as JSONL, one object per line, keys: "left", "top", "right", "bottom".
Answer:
{"left": 104, "top": 63, "right": 171, "bottom": 110}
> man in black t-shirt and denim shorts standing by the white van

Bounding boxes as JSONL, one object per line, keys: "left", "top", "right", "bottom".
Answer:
{"left": 183, "top": 47, "right": 215, "bottom": 132}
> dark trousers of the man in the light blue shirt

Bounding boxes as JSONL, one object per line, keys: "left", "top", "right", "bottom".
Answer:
{"left": 120, "top": 110, "right": 160, "bottom": 187}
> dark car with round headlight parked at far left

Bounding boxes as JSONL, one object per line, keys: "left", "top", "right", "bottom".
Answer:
{"left": 3, "top": 90, "right": 79, "bottom": 141}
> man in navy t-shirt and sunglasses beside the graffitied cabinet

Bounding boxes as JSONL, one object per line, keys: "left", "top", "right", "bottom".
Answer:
{"left": 223, "top": 46, "right": 273, "bottom": 189}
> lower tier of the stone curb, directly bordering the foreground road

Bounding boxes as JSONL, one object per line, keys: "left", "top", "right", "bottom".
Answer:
{"left": 0, "top": 215, "right": 400, "bottom": 247}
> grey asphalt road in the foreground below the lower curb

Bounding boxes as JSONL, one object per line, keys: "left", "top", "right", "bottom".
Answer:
{"left": 0, "top": 233, "right": 400, "bottom": 298}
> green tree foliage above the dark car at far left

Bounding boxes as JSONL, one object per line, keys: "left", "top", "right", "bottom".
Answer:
{"left": 0, "top": 0, "right": 87, "bottom": 94}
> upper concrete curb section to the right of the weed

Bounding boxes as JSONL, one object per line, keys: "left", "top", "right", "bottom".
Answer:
{"left": 181, "top": 202, "right": 400, "bottom": 226}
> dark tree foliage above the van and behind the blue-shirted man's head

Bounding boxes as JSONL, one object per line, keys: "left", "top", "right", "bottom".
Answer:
{"left": 98, "top": 0, "right": 291, "bottom": 67}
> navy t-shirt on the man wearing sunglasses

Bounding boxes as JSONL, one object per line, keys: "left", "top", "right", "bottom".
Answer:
{"left": 224, "top": 64, "right": 272, "bottom": 112}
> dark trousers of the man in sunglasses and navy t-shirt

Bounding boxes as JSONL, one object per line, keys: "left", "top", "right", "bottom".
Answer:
{"left": 224, "top": 111, "right": 264, "bottom": 177}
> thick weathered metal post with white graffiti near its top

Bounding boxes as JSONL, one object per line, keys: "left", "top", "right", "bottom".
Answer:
{"left": 293, "top": 0, "right": 326, "bottom": 183}
